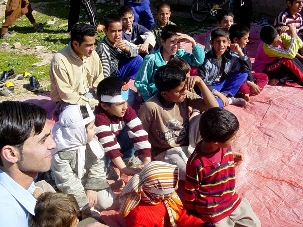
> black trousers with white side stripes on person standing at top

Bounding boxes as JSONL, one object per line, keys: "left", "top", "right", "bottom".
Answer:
{"left": 67, "top": 0, "right": 98, "bottom": 32}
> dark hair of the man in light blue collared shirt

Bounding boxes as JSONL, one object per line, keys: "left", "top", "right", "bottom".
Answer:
{"left": 0, "top": 101, "right": 47, "bottom": 166}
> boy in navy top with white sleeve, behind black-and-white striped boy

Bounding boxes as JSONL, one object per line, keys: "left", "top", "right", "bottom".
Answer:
{"left": 118, "top": 5, "right": 156, "bottom": 55}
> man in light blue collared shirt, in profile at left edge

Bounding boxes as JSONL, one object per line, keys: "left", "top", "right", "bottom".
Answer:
{"left": 0, "top": 101, "right": 56, "bottom": 227}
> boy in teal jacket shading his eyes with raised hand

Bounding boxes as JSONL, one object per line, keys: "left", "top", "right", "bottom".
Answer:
{"left": 135, "top": 25, "right": 205, "bottom": 101}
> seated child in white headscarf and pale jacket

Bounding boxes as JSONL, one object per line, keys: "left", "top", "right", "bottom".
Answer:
{"left": 51, "top": 104, "right": 123, "bottom": 217}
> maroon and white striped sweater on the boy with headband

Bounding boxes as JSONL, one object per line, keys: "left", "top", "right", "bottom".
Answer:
{"left": 95, "top": 105, "right": 151, "bottom": 159}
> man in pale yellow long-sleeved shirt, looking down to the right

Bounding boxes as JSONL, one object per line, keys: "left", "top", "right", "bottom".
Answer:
{"left": 49, "top": 24, "right": 103, "bottom": 114}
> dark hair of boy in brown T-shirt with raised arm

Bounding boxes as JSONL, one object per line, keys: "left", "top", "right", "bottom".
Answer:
{"left": 154, "top": 65, "right": 186, "bottom": 92}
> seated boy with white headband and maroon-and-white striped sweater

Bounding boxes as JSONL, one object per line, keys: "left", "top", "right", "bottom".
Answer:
{"left": 94, "top": 77, "right": 151, "bottom": 175}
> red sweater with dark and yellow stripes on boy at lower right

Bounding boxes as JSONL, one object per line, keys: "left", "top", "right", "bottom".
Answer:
{"left": 185, "top": 145, "right": 241, "bottom": 223}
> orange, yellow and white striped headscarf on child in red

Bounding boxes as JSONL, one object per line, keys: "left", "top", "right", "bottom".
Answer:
{"left": 119, "top": 161, "right": 183, "bottom": 226}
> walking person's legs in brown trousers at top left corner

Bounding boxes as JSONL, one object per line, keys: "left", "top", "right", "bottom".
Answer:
{"left": 1, "top": 0, "right": 40, "bottom": 38}
